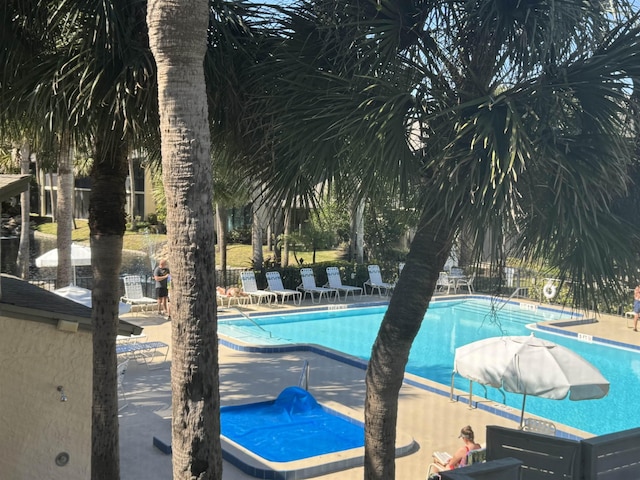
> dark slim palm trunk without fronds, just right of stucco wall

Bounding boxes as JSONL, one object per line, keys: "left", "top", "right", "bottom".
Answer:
{"left": 89, "top": 131, "right": 127, "bottom": 480}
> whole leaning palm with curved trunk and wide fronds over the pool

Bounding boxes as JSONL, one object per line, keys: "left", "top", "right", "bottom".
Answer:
{"left": 258, "top": 0, "right": 640, "bottom": 480}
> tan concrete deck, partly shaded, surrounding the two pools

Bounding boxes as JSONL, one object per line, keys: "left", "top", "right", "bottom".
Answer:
{"left": 120, "top": 296, "right": 640, "bottom": 480}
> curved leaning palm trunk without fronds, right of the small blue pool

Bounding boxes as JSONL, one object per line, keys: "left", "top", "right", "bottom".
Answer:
{"left": 364, "top": 212, "right": 452, "bottom": 480}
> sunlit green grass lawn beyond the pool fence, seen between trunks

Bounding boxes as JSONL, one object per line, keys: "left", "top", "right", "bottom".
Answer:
{"left": 37, "top": 220, "right": 340, "bottom": 268}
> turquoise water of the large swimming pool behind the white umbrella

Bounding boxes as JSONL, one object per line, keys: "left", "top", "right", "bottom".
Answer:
{"left": 219, "top": 299, "right": 640, "bottom": 435}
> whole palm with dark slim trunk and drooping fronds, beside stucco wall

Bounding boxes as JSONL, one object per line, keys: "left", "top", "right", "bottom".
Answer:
{"left": 0, "top": 0, "right": 157, "bottom": 479}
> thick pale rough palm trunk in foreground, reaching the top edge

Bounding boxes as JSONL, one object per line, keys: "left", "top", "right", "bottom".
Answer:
{"left": 147, "top": 0, "right": 222, "bottom": 480}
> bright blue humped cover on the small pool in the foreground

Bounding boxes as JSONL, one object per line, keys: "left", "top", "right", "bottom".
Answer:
{"left": 220, "top": 387, "right": 364, "bottom": 462}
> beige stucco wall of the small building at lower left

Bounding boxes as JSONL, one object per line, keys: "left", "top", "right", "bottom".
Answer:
{"left": 0, "top": 316, "right": 92, "bottom": 480}
